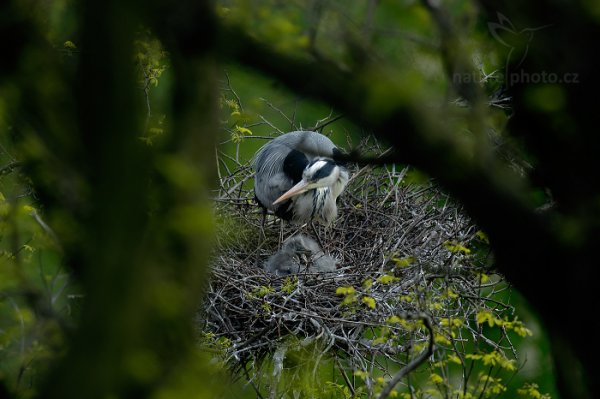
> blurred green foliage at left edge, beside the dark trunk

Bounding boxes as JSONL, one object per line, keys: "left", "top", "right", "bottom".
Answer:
{"left": 0, "top": 146, "right": 70, "bottom": 397}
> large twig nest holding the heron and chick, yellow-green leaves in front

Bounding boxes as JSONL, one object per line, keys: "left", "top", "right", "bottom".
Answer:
{"left": 202, "top": 139, "right": 499, "bottom": 392}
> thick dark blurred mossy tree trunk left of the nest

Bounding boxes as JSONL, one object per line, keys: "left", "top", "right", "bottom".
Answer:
{"left": 32, "top": 0, "right": 218, "bottom": 399}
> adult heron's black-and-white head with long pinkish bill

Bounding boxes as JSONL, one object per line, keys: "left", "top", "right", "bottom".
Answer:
{"left": 273, "top": 158, "right": 341, "bottom": 205}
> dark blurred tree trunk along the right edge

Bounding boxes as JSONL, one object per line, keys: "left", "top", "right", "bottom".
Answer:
{"left": 478, "top": 0, "right": 600, "bottom": 399}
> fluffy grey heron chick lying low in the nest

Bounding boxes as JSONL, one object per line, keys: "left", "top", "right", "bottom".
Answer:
{"left": 264, "top": 234, "right": 337, "bottom": 276}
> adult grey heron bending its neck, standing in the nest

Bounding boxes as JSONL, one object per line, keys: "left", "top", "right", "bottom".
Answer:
{"left": 254, "top": 131, "right": 349, "bottom": 225}
